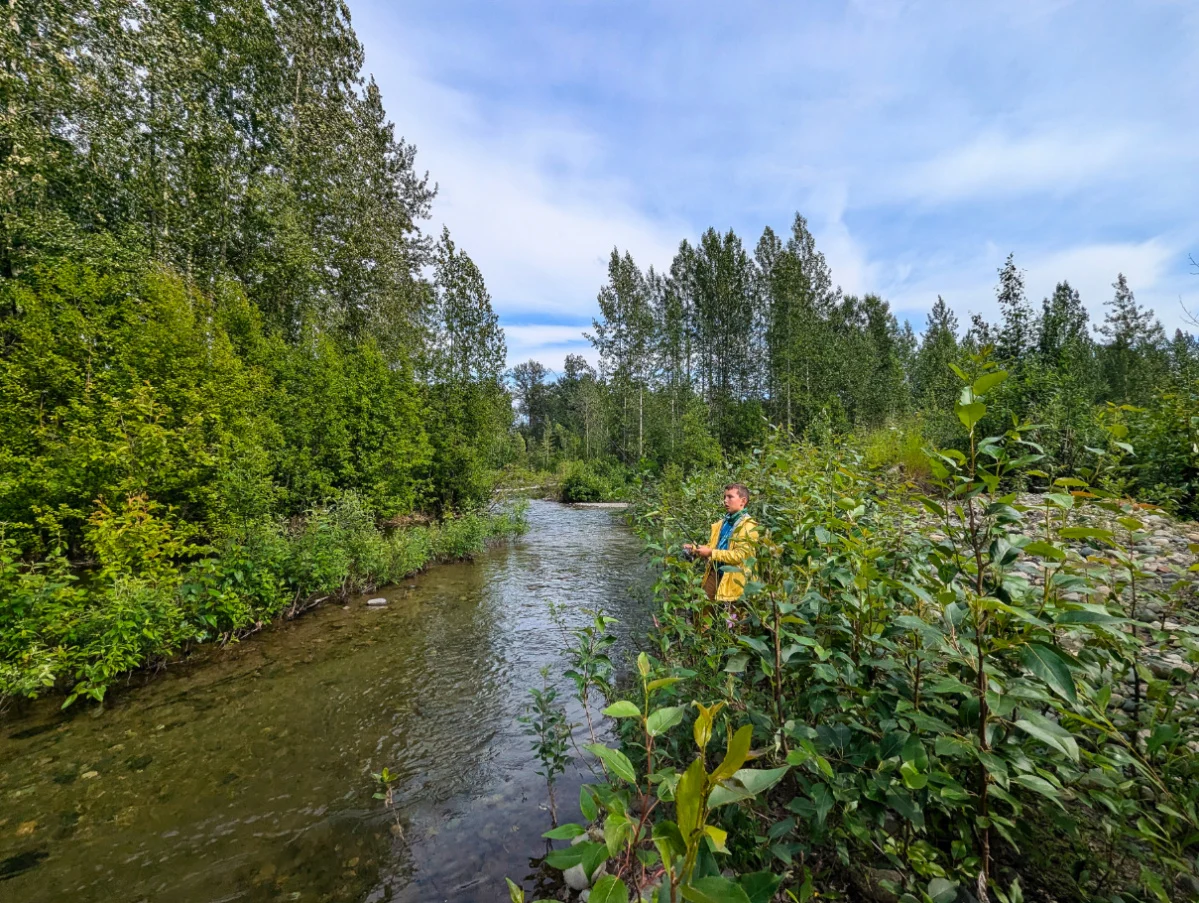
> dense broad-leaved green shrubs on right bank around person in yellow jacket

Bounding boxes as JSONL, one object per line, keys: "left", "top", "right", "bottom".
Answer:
{"left": 522, "top": 355, "right": 1199, "bottom": 903}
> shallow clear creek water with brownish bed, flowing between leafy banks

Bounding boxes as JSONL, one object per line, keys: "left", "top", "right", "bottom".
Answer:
{"left": 0, "top": 501, "right": 650, "bottom": 903}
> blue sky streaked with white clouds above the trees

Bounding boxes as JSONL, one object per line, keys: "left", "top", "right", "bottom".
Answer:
{"left": 349, "top": 0, "right": 1199, "bottom": 369}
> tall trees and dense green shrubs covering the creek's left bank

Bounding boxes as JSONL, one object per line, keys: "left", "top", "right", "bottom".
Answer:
{"left": 0, "top": 0, "right": 512, "bottom": 698}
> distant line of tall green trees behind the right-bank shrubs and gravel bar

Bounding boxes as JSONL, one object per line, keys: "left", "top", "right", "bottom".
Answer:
{"left": 513, "top": 216, "right": 1199, "bottom": 507}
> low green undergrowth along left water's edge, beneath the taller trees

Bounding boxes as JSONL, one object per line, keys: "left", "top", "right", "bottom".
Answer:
{"left": 0, "top": 493, "right": 525, "bottom": 710}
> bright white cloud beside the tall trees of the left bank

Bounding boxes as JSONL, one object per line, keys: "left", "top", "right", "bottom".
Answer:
{"left": 363, "top": 53, "right": 687, "bottom": 319}
